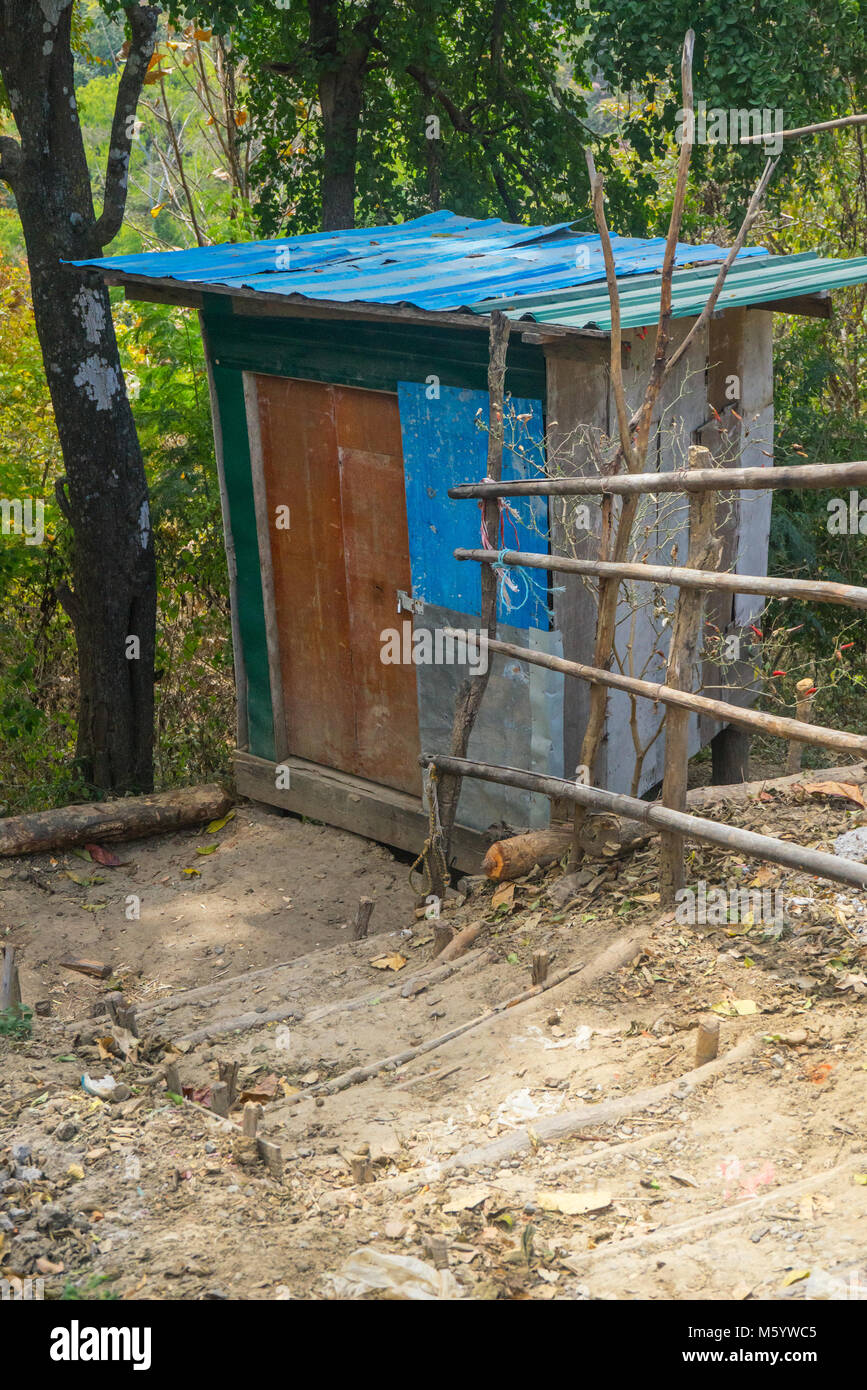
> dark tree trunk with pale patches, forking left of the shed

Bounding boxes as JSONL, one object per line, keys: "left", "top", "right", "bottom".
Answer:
{"left": 0, "top": 0, "right": 157, "bottom": 792}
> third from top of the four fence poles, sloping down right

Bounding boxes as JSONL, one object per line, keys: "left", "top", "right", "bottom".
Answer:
{"left": 443, "top": 627, "right": 867, "bottom": 756}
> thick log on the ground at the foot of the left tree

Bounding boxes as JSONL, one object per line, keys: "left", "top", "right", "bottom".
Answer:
{"left": 0, "top": 784, "right": 232, "bottom": 855}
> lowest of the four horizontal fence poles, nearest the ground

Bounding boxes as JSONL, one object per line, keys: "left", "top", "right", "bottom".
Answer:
{"left": 418, "top": 753, "right": 867, "bottom": 888}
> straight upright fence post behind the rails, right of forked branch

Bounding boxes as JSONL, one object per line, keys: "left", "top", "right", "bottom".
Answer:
{"left": 660, "top": 445, "right": 717, "bottom": 906}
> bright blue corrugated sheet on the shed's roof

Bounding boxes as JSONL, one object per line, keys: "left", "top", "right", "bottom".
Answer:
{"left": 75, "top": 210, "right": 767, "bottom": 310}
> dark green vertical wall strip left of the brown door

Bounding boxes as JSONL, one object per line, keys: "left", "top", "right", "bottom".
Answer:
{"left": 208, "top": 358, "right": 276, "bottom": 760}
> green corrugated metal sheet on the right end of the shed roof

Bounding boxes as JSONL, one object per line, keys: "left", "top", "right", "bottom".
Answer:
{"left": 475, "top": 252, "right": 867, "bottom": 331}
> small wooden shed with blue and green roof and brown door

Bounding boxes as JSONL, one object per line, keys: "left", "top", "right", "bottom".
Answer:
{"left": 77, "top": 211, "right": 867, "bottom": 866}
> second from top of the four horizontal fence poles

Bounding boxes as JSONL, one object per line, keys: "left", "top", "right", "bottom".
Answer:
{"left": 453, "top": 548, "right": 867, "bottom": 609}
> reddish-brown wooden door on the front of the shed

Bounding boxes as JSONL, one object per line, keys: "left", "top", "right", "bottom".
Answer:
{"left": 256, "top": 377, "right": 421, "bottom": 792}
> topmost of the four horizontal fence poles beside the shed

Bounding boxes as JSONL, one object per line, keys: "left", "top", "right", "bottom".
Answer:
{"left": 449, "top": 459, "right": 867, "bottom": 499}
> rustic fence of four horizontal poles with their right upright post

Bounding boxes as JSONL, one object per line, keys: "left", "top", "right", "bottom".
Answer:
{"left": 436, "top": 445, "right": 867, "bottom": 905}
